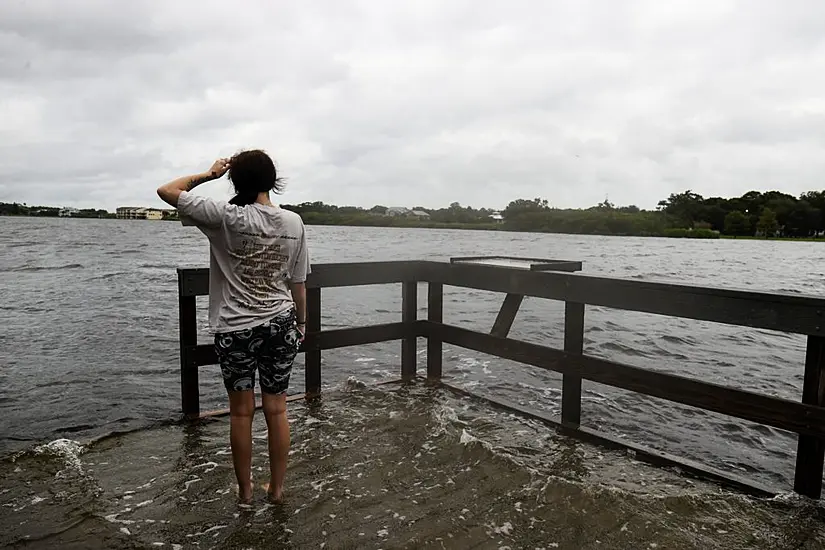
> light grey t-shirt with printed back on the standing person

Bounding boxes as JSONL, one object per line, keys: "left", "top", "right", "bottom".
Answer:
{"left": 178, "top": 191, "right": 310, "bottom": 333}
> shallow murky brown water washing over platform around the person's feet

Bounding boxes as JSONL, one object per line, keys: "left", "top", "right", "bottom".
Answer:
{"left": 0, "top": 383, "right": 825, "bottom": 549}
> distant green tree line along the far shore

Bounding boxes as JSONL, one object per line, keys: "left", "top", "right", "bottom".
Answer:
{"left": 6, "top": 190, "right": 825, "bottom": 238}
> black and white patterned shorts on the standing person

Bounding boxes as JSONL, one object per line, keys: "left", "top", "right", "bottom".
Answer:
{"left": 215, "top": 309, "right": 301, "bottom": 394}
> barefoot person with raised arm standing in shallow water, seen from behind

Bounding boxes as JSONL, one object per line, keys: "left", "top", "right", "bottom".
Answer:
{"left": 158, "top": 150, "right": 310, "bottom": 503}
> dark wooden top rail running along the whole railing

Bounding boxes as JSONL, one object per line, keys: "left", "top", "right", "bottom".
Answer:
{"left": 178, "top": 261, "right": 825, "bottom": 336}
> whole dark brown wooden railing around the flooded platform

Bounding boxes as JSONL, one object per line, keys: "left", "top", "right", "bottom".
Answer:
{"left": 178, "top": 259, "right": 825, "bottom": 498}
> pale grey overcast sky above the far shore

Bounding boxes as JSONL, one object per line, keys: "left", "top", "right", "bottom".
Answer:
{"left": 0, "top": 0, "right": 825, "bottom": 209}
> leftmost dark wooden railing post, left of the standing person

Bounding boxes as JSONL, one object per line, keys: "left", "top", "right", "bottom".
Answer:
{"left": 178, "top": 282, "right": 200, "bottom": 418}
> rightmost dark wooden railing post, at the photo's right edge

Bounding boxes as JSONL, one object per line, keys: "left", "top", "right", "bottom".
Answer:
{"left": 794, "top": 336, "right": 825, "bottom": 499}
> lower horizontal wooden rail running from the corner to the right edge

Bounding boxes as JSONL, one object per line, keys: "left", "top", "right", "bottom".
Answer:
{"left": 424, "top": 323, "right": 825, "bottom": 438}
